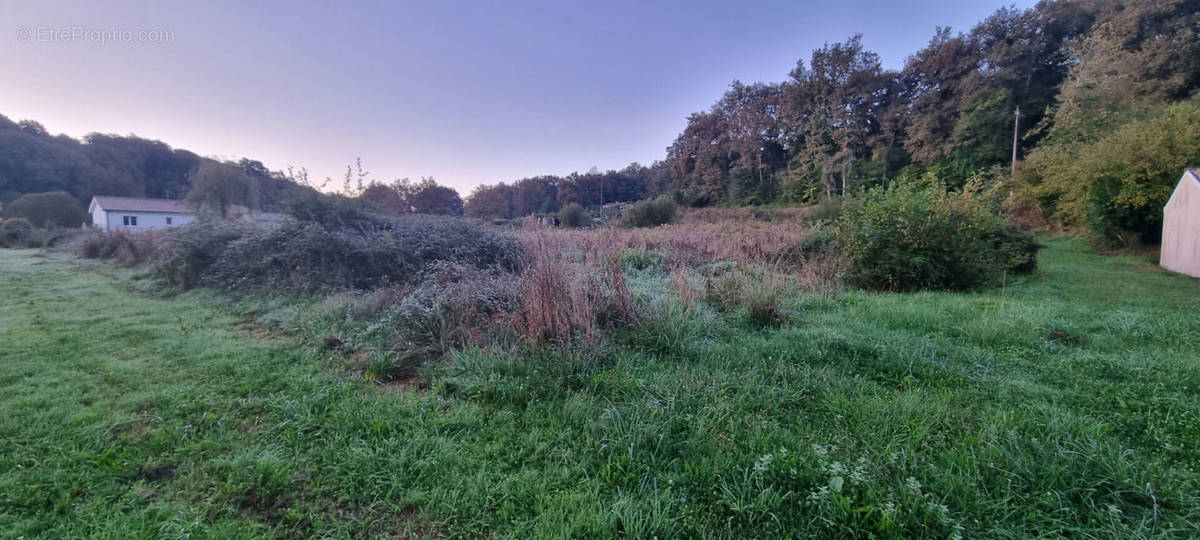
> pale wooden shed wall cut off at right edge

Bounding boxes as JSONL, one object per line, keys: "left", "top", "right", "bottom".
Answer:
{"left": 1159, "top": 169, "right": 1200, "bottom": 277}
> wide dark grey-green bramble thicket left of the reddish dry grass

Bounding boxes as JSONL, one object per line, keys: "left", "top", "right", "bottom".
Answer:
{"left": 160, "top": 216, "right": 522, "bottom": 292}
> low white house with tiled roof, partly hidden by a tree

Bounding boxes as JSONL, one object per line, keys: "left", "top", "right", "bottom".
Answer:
{"left": 88, "top": 196, "right": 283, "bottom": 229}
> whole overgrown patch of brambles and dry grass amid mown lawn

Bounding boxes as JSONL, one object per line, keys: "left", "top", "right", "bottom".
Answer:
{"left": 65, "top": 205, "right": 845, "bottom": 380}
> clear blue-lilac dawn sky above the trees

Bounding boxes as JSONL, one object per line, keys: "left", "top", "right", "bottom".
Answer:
{"left": 0, "top": 0, "right": 1033, "bottom": 194}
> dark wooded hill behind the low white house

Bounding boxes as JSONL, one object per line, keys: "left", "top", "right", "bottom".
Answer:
{"left": 0, "top": 115, "right": 462, "bottom": 222}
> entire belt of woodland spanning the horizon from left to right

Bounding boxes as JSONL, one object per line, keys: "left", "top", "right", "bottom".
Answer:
{"left": 0, "top": 0, "right": 1200, "bottom": 242}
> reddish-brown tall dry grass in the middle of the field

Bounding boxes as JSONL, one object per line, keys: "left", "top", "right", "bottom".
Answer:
{"left": 508, "top": 209, "right": 845, "bottom": 343}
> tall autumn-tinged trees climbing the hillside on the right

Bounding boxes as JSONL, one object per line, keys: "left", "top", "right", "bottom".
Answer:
{"left": 467, "top": 0, "right": 1200, "bottom": 244}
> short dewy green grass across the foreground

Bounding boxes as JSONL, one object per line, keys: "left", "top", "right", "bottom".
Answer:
{"left": 0, "top": 240, "right": 1200, "bottom": 538}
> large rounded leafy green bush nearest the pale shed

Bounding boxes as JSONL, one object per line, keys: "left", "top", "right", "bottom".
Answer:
{"left": 838, "top": 185, "right": 1037, "bottom": 290}
